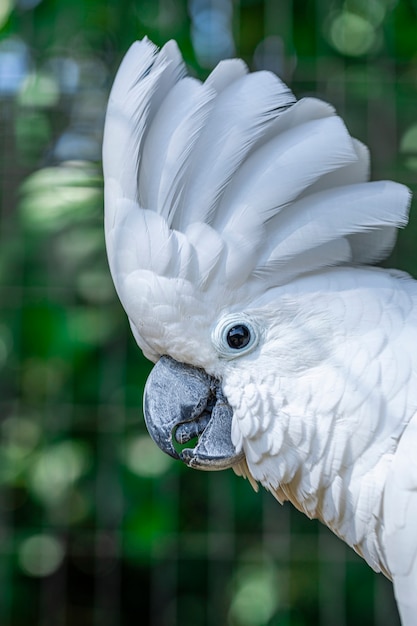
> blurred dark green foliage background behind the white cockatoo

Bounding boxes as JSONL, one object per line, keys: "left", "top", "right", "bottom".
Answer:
{"left": 0, "top": 0, "right": 417, "bottom": 626}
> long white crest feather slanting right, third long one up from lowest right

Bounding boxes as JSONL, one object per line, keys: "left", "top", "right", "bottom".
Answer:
{"left": 173, "top": 72, "right": 294, "bottom": 230}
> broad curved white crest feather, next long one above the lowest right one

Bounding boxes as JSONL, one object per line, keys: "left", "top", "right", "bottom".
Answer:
{"left": 213, "top": 116, "right": 356, "bottom": 232}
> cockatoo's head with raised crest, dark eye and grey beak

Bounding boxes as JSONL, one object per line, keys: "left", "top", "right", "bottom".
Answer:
{"left": 103, "top": 39, "right": 409, "bottom": 480}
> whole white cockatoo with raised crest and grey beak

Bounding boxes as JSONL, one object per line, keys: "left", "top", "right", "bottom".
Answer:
{"left": 103, "top": 39, "right": 417, "bottom": 626}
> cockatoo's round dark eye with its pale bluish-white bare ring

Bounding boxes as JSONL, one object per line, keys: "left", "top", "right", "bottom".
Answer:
{"left": 212, "top": 313, "right": 260, "bottom": 359}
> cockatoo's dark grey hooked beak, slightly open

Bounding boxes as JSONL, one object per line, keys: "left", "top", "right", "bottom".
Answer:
{"left": 144, "top": 356, "right": 243, "bottom": 470}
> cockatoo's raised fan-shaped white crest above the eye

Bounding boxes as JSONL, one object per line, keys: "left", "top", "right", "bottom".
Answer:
{"left": 103, "top": 39, "right": 410, "bottom": 353}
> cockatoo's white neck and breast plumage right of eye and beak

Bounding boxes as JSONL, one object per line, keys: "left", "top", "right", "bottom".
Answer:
{"left": 228, "top": 268, "right": 417, "bottom": 572}
